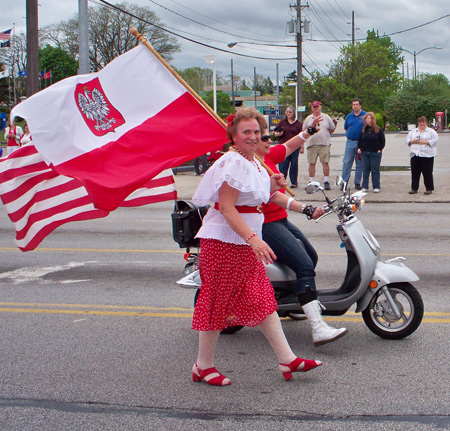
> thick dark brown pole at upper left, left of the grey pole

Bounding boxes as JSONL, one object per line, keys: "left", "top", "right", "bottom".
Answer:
{"left": 25, "top": 0, "right": 39, "bottom": 98}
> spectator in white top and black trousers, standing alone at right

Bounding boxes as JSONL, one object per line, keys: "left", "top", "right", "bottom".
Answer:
{"left": 406, "top": 117, "right": 439, "bottom": 195}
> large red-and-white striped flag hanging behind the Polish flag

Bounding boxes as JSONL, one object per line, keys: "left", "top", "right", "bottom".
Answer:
{"left": 0, "top": 144, "right": 177, "bottom": 251}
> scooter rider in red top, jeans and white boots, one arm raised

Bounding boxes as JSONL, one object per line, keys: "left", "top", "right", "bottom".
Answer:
{"left": 256, "top": 127, "right": 348, "bottom": 346}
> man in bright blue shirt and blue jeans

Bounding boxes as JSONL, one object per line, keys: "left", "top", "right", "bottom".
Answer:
{"left": 342, "top": 99, "right": 366, "bottom": 190}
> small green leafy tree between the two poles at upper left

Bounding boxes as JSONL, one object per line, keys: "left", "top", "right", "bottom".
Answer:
{"left": 39, "top": 45, "right": 78, "bottom": 83}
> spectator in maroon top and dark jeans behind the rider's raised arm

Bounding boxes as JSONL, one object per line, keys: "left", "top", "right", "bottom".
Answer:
{"left": 273, "top": 106, "right": 303, "bottom": 189}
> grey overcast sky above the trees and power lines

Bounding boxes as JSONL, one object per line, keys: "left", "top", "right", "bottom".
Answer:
{"left": 0, "top": 0, "right": 450, "bottom": 86}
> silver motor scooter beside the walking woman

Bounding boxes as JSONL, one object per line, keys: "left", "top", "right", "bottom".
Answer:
{"left": 177, "top": 177, "right": 424, "bottom": 340}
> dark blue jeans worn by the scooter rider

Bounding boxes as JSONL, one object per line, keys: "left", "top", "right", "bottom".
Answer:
{"left": 263, "top": 218, "right": 319, "bottom": 294}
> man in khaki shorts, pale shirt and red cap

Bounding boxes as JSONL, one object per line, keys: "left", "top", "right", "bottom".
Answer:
{"left": 303, "top": 100, "right": 336, "bottom": 190}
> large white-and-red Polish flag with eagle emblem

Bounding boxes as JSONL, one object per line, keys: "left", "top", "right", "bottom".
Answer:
{"left": 11, "top": 45, "right": 228, "bottom": 211}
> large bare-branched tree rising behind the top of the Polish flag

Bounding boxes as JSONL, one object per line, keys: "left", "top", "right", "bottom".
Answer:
{"left": 39, "top": 2, "right": 179, "bottom": 71}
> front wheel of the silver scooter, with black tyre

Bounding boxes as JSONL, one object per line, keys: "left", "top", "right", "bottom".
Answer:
{"left": 362, "top": 283, "right": 424, "bottom": 340}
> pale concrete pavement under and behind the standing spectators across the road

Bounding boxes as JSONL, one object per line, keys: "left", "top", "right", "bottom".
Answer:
{"left": 175, "top": 132, "right": 450, "bottom": 203}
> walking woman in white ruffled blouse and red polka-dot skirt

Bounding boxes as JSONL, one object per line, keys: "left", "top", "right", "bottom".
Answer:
{"left": 192, "top": 108, "right": 322, "bottom": 386}
